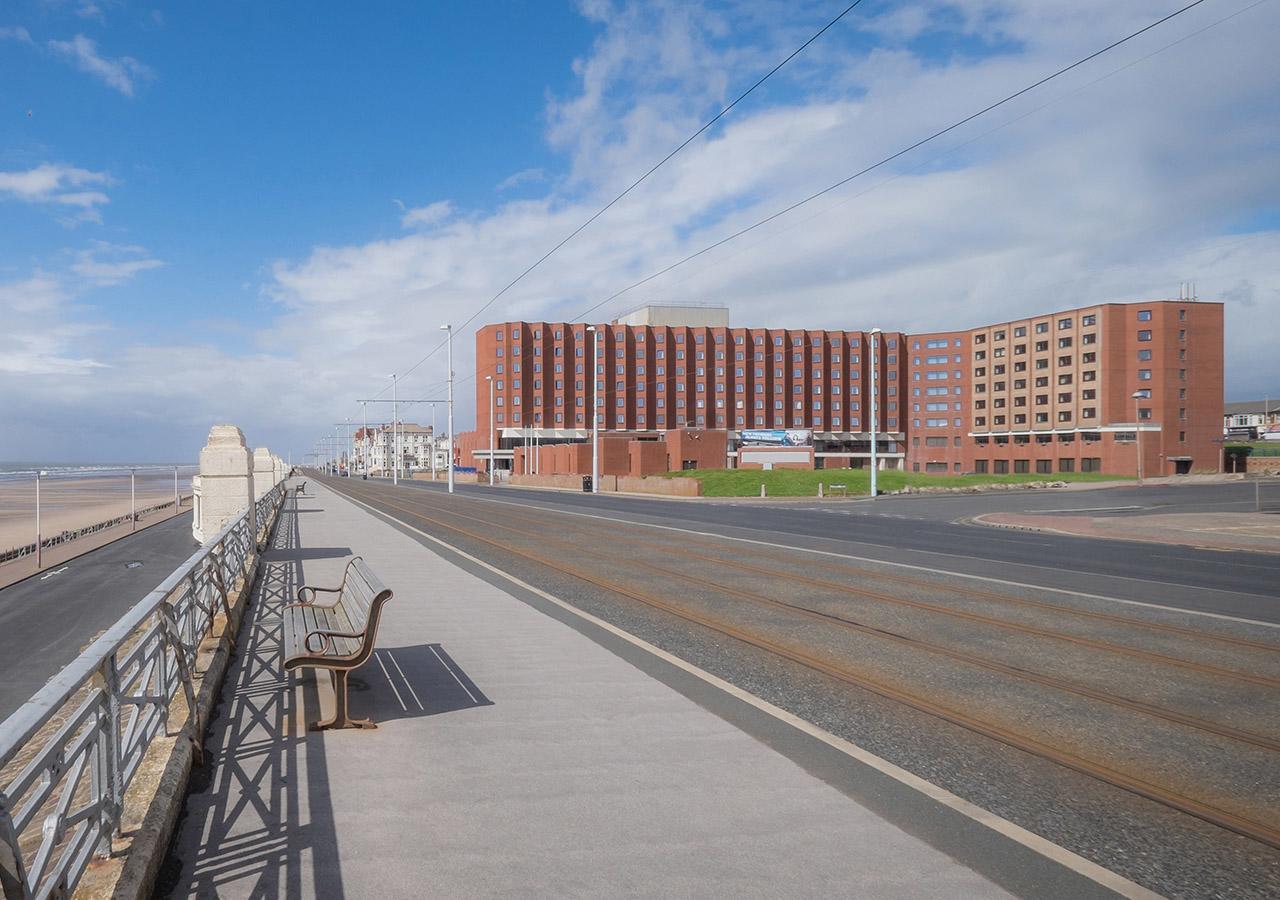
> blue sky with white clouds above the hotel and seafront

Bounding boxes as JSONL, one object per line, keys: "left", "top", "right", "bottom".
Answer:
{"left": 0, "top": 0, "right": 1280, "bottom": 461}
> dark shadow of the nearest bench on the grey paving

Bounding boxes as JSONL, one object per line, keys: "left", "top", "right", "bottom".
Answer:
{"left": 358, "top": 644, "right": 493, "bottom": 722}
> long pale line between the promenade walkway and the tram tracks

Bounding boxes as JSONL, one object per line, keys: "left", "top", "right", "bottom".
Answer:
{"left": 334, "top": 481, "right": 1160, "bottom": 900}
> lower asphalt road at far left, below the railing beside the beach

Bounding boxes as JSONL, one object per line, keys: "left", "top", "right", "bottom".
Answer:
{"left": 0, "top": 512, "right": 197, "bottom": 719}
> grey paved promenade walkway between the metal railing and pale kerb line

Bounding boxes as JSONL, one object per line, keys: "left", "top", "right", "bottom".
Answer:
{"left": 157, "top": 481, "right": 1131, "bottom": 899}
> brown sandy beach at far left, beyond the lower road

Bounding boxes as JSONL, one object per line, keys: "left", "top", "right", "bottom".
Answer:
{"left": 0, "top": 472, "right": 191, "bottom": 552}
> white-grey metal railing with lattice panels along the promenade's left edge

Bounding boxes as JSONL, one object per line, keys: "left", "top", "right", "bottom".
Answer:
{"left": 0, "top": 484, "right": 284, "bottom": 900}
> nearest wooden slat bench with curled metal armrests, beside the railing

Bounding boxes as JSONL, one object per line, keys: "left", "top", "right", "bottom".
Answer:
{"left": 283, "top": 557, "right": 392, "bottom": 731}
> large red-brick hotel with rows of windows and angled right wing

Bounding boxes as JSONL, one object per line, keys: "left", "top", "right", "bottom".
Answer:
{"left": 462, "top": 301, "right": 1222, "bottom": 476}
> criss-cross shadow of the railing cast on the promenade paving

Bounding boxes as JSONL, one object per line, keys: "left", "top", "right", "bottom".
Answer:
{"left": 156, "top": 495, "right": 349, "bottom": 897}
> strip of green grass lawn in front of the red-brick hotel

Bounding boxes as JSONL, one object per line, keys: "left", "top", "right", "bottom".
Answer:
{"left": 667, "top": 469, "right": 1133, "bottom": 497}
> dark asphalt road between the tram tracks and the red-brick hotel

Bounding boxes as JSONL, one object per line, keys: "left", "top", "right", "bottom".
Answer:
{"left": 355, "top": 481, "right": 1280, "bottom": 625}
